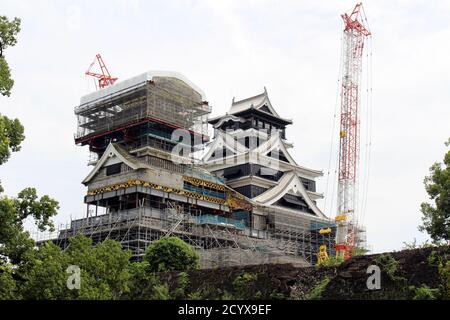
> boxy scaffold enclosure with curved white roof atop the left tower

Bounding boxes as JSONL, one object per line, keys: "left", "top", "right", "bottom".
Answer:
{"left": 75, "top": 74, "right": 211, "bottom": 149}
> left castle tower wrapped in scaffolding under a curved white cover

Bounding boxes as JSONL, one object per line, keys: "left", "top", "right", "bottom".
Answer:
{"left": 46, "top": 72, "right": 262, "bottom": 259}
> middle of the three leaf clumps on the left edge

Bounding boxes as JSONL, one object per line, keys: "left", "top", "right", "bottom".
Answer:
{"left": 0, "top": 114, "right": 25, "bottom": 165}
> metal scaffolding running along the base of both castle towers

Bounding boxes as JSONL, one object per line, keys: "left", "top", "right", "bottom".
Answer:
{"left": 35, "top": 201, "right": 335, "bottom": 268}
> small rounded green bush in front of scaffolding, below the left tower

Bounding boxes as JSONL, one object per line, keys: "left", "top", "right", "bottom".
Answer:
{"left": 144, "top": 237, "right": 199, "bottom": 272}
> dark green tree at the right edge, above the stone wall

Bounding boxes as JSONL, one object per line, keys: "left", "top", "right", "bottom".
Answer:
{"left": 419, "top": 139, "right": 450, "bottom": 243}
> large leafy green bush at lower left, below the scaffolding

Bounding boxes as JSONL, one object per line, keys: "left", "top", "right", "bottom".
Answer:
{"left": 20, "top": 235, "right": 131, "bottom": 300}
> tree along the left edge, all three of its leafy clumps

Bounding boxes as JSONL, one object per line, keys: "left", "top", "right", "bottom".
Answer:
{"left": 0, "top": 16, "right": 59, "bottom": 265}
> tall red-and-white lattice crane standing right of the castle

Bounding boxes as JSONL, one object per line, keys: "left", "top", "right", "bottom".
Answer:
{"left": 336, "top": 3, "right": 371, "bottom": 259}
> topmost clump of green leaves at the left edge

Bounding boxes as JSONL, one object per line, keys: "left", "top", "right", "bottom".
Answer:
{"left": 0, "top": 16, "right": 20, "bottom": 96}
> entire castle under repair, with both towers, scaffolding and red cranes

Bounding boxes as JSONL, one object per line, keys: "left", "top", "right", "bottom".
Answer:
{"left": 36, "top": 4, "right": 371, "bottom": 268}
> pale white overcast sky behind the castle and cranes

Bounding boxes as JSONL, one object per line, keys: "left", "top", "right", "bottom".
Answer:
{"left": 0, "top": 0, "right": 450, "bottom": 252}
